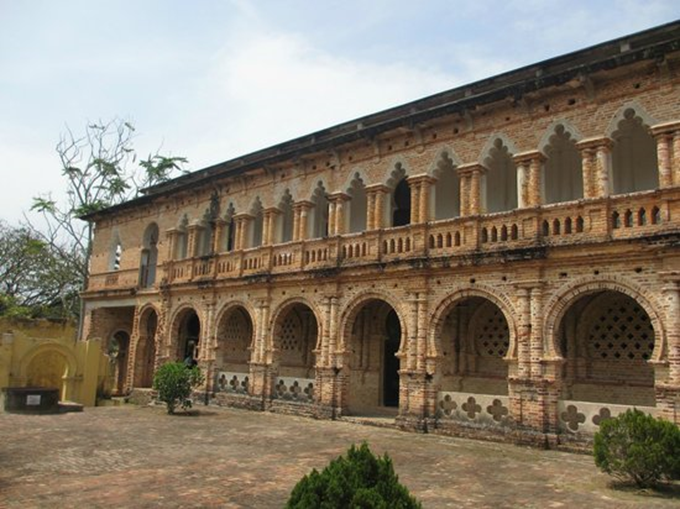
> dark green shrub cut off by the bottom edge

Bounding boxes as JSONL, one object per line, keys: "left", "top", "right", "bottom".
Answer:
{"left": 286, "top": 443, "right": 421, "bottom": 509}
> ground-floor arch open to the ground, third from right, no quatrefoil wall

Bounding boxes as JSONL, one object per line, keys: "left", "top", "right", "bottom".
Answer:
{"left": 346, "top": 299, "right": 403, "bottom": 415}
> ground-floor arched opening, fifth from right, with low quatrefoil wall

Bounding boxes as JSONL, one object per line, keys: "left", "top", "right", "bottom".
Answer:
{"left": 214, "top": 306, "right": 253, "bottom": 394}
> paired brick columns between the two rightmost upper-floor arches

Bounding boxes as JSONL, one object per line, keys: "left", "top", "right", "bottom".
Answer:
{"left": 576, "top": 137, "right": 613, "bottom": 198}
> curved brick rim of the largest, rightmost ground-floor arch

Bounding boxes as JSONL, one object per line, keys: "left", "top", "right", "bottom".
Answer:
{"left": 543, "top": 276, "right": 666, "bottom": 361}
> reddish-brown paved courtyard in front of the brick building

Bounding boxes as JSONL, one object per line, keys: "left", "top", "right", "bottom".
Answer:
{"left": 0, "top": 406, "right": 680, "bottom": 509}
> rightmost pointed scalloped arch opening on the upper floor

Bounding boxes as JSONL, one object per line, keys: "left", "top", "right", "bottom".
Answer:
{"left": 610, "top": 107, "right": 659, "bottom": 194}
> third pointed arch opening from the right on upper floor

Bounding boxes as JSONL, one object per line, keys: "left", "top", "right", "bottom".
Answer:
{"left": 481, "top": 135, "right": 518, "bottom": 212}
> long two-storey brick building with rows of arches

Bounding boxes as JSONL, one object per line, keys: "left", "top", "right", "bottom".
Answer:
{"left": 83, "top": 22, "right": 680, "bottom": 443}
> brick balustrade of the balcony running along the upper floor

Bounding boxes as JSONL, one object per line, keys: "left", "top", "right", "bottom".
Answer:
{"left": 88, "top": 187, "right": 680, "bottom": 292}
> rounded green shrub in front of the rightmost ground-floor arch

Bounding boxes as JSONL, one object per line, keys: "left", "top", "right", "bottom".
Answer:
{"left": 594, "top": 409, "right": 680, "bottom": 488}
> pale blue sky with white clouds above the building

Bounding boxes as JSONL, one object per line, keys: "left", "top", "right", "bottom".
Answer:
{"left": 0, "top": 0, "right": 680, "bottom": 224}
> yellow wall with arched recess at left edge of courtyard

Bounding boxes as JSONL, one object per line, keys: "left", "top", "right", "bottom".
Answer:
{"left": 0, "top": 318, "right": 109, "bottom": 406}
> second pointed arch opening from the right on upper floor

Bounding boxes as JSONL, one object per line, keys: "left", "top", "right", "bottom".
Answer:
{"left": 540, "top": 122, "right": 583, "bottom": 203}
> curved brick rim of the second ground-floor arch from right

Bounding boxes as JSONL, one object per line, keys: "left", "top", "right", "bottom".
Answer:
{"left": 427, "top": 285, "right": 517, "bottom": 359}
